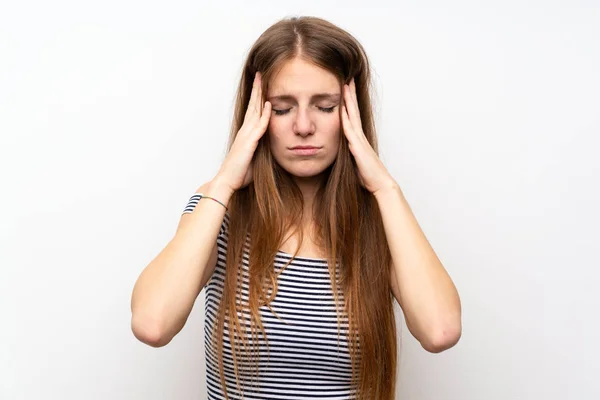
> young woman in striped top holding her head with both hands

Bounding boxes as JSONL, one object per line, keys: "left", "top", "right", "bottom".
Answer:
{"left": 132, "top": 17, "right": 461, "bottom": 399}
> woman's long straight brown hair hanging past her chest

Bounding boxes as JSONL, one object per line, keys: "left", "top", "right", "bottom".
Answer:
{"left": 212, "top": 17, "right": 397, "bottom": 400}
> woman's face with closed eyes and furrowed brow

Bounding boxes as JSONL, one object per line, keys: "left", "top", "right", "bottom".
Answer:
{"left": 266, "top": 58, "right": 342, "bottom": 178}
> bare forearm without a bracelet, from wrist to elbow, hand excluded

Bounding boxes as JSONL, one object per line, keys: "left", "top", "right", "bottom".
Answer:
{"left": 375, "top": 186, "right": 462, "bottom": 353}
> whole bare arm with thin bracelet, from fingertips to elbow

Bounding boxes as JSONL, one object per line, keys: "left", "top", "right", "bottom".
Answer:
{"left": 131, "top": 71, "right": 271, "bottom": 347}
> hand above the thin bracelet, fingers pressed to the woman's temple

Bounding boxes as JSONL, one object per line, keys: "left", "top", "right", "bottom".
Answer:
{"left": 215, "top": 72, "right": 271, "bottom": 193}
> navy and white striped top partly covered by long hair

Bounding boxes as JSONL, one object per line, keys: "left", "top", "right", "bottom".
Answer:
{"left": 184, "top": 195, "right": 354, "bottom": 400}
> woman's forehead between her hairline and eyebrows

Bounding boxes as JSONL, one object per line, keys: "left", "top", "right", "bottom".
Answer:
{"left": 269, "top": 58, "right": 340, "bottom": 97}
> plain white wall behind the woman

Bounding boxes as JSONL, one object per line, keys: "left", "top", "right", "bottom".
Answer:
{"left": 0, "top": 0, "right": 600, "bottom": 400}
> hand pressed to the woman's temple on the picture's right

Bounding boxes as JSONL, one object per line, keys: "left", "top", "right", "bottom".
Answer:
{"left": 341, "top": 78, "right": 396, "bottom": 194}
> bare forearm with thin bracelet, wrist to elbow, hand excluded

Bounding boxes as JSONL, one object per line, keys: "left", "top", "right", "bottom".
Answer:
{"left": 131, "top": 180, "right": 232, "bottom": 347}
